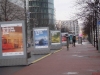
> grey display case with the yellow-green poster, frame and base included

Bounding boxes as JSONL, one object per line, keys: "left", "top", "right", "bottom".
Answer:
{"left": 50, "top": 31, "right": 62, "bottom": 50}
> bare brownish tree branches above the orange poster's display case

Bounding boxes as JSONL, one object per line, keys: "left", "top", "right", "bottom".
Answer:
{"left": 0, "top": 0, "right": 25, "bottom": 21}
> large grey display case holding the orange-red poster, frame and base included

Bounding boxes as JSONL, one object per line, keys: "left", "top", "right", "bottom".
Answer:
{"left": 0, "top": 21, "right": 27, "bottom": 66}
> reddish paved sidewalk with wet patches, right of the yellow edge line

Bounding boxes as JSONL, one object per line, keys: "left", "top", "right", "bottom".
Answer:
{"left": 12, "top": 43, "right": 100, "bottom": 75}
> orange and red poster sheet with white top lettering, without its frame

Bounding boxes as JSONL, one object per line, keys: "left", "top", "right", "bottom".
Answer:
{"left": 1, "top": 23, "right": 24, "bottom": 56}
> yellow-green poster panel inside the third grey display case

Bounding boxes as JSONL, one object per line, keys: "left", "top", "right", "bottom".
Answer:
{"left": 51, "top": 31, "right": 60, "bottom": 44}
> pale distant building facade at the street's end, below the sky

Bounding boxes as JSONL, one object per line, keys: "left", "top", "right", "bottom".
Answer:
{"left": 56, "top": 20, "right": 79, "bottom": 36}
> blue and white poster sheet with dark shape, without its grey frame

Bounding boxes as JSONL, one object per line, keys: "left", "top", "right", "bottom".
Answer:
{"left": 34, "top": 29, "right": 48, "bottom": 48}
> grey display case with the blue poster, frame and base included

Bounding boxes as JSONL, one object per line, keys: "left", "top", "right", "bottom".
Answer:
{"left": 33, "top": 27, "right": 50, "bottom": 54}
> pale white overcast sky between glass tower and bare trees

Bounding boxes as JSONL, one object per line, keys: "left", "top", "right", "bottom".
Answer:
{"left": 54, "top": 0, "right": 77, "bottom": 20}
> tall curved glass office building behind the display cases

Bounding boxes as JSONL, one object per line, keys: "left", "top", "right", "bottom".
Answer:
{"left": 29, "top": 0, "right": 54, "bottom": 29}
